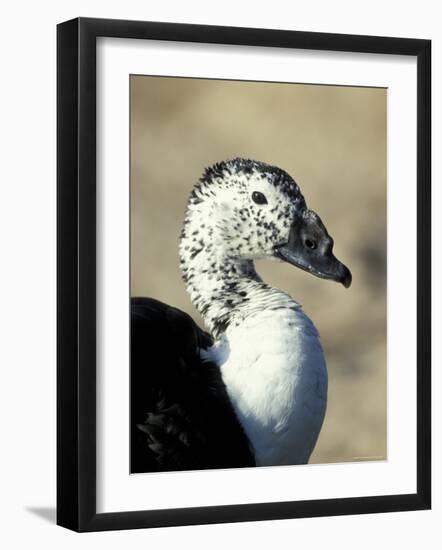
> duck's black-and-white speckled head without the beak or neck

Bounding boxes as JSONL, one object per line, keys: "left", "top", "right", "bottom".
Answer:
{"left": 181, "top": 159, "right": 305, "bottom": 259}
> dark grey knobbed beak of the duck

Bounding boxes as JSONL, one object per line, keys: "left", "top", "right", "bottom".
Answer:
{"left": 275, "top": 210, "right": 352, "bottom": 288}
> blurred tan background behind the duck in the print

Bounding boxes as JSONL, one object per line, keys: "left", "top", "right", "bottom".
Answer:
{"left": 131, "top": 76, "right": 386, "bottom": 463}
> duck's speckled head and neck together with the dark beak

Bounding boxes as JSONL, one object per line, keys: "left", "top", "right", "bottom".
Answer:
{"left": 180, "top": 158, "right": 351, "bottom": 336}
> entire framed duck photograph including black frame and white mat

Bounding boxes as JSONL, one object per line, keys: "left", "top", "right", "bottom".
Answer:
{"left": 57, "top": 18, "right": 431, "bottom": 531}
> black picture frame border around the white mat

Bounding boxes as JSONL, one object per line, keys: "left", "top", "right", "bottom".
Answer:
{"left": 57, "top": 18, "right": 431, "bottom": 531}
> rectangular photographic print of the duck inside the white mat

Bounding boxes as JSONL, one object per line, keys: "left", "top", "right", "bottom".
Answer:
{"left": 130, "top": 75, "right": 387, "bottom": 473}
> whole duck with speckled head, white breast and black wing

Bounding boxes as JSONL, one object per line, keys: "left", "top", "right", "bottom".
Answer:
{"left": 130, "top": 158, "right": 352, "bottom": 473}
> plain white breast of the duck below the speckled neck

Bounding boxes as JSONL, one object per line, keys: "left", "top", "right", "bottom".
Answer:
{"left": 205, "top": 306, "right": 327, "bottom": 466}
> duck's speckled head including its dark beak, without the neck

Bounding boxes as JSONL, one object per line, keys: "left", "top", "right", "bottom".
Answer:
{"left": 181, "top": 159, "right": 352, "bottom": 288}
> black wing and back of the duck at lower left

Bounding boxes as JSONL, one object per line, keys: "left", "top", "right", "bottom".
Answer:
{"left": 130, "top": 298, "right": 255, "bottom": 473}
